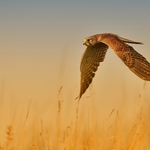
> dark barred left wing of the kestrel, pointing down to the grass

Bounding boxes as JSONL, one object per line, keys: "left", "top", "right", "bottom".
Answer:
{"left": 79, "top": 43, "right": 108, "bottom": 99}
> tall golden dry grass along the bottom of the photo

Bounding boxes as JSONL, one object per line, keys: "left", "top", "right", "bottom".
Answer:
{"left": 0, "top": 88, "right": 150, "bottom": 150}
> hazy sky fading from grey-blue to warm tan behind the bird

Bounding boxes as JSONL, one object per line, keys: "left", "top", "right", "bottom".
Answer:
{"left": 0, "top": 0, "right": 150, "bottom": 122}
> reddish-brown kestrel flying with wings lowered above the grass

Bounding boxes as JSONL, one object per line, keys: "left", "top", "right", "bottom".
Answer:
{"left": 78, "top": 33, "right": 150, "bottom": 99}
